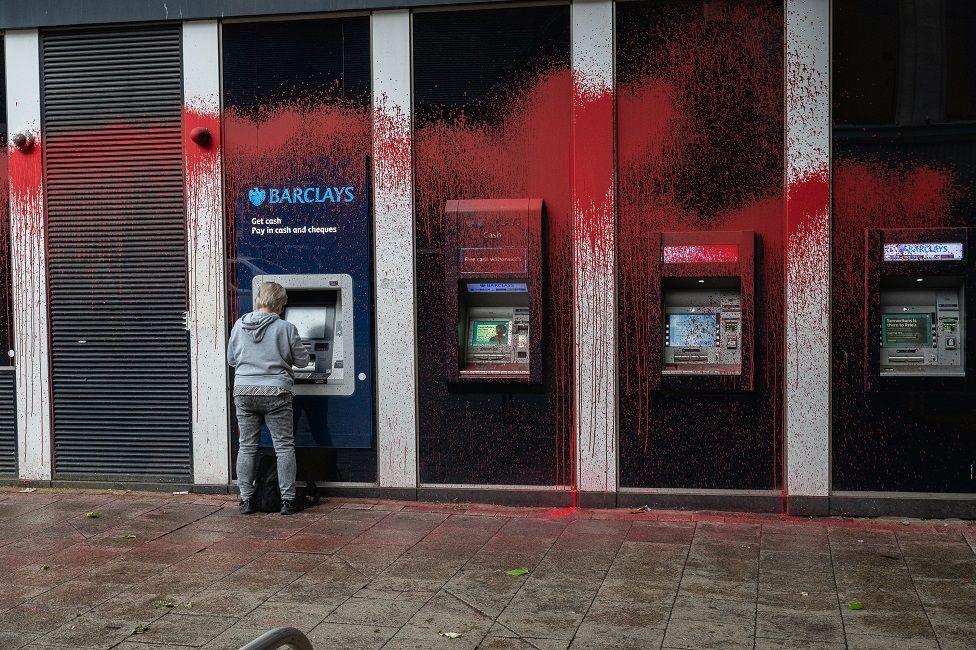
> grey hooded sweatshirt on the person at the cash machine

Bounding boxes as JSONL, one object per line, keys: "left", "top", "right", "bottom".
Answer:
{"left": 227, "top": 311, "right": 309, "bottom": 391}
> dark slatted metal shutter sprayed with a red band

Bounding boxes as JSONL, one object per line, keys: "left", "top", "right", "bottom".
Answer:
{"left": 41, "top": 24, "right": 192, "bottom": 482}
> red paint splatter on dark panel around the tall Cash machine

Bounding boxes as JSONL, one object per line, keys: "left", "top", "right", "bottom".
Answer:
{"left": 414, "top": 69, "right": 575, "bottom": 486}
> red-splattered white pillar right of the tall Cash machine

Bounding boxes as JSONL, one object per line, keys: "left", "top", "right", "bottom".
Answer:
{"left": 572, "top": 0, "right": 617, "bottom": 505}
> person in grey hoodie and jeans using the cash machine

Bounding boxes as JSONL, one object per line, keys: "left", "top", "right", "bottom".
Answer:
{"left": 227, "top": 282, "right": 310, "bottom": 515}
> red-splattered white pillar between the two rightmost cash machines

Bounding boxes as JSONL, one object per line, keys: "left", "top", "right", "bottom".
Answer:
{"left": 785, "top": 0, "right": 831, "bottom": 514}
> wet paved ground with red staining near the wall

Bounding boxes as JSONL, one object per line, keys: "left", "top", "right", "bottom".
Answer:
{"left": 0, "top": 490, "right": 976, "bottom": 650}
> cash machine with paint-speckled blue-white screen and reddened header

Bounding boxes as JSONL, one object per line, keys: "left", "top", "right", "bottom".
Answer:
{"left": 648, "top": 231, "right": 756, "bottom": 390}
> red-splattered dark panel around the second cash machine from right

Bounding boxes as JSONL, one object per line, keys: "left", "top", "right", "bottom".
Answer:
{"left": 617, "top": 1, "right": 784, "bottom": 489}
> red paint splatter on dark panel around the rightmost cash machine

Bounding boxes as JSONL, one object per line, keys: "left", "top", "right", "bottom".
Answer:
{"left": 831, "top": 159, "right": 973, "bottom": 492}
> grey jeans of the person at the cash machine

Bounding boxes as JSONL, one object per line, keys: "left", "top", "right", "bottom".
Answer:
{"left": 234, "top": 393, "right": 296, "bottom": 501}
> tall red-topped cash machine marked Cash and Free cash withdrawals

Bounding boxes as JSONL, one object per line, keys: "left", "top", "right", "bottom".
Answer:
{"left": 444, "top": 199, "right": 543, "bottom": 385}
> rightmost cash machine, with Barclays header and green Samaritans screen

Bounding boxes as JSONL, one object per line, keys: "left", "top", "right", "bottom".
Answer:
{"left": 865, "top": 228, "right": 974, "bottom": 390}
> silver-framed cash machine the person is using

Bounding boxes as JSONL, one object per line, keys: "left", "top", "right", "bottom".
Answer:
{"left": 252, "top": 273, "right": 356, "bottom": 396}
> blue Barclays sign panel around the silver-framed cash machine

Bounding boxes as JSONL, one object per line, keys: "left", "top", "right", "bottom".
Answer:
{"left": 234, "top": 159, "right": 375, "bottom": 449}
